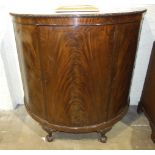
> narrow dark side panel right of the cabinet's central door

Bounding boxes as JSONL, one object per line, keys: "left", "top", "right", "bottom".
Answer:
{"left": 108, "top": 22, "right": 140, "bottom": 119}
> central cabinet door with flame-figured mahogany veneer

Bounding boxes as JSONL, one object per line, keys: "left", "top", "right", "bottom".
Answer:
{"left": 38, "top": 25, "right": 114, "bottom": 126}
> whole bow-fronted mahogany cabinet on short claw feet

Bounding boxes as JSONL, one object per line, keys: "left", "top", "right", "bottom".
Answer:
{"left": 11, "top": 9, "right": 146, "bottom": 142}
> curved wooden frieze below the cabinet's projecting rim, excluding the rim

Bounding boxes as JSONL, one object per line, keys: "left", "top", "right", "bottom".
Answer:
{"left": 12, "top": 13, "right": 143, "bottom": 26}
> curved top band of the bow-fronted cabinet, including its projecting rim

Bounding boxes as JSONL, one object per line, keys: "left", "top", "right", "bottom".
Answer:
{"left": 11, "top": 10, "right": 146, "bottom": 26}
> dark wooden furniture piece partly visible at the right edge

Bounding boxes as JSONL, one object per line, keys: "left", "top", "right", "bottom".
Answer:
{"left": 138, "top": 42, "right": 155, "bottom": 142}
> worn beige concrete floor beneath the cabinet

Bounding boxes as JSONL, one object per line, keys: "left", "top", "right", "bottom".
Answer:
{"left": 0, "top": 106, "right": 155, "bottom": 150}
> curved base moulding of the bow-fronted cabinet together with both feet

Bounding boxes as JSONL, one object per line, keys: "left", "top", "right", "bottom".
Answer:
{"left": 25, "top": 104, "right": 129, "bottom": 143}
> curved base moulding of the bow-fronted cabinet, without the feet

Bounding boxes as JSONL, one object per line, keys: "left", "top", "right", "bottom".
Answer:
{"left": 25, "top": 101, "right": 129, "bottom": 133}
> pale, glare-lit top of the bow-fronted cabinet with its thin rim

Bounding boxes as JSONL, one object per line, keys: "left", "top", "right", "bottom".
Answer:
{"left": 10, "top": 8, "right": 146, "bottom": 17}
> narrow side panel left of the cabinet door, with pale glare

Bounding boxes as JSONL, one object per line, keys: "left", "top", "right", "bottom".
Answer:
{"left": 14, "top": 24, "right": 45, "bottom": 118}
